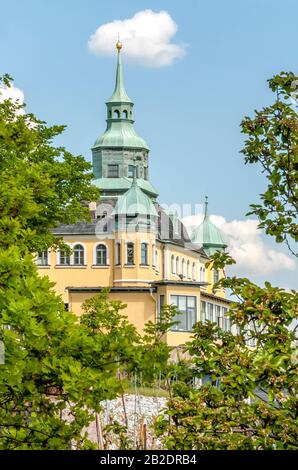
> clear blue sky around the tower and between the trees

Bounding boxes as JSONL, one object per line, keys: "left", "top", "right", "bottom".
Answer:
{"left": 0, "top": 0, "right": 298, "bottom": 287}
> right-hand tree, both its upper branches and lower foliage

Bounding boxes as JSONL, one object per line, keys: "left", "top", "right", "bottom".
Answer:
{"left": 156, "top": 73, "right": 298, "bottom": 450}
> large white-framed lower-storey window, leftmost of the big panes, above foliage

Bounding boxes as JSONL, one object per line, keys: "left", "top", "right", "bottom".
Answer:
{"left": 171, "top": 295, "right": 197, "bottom": 331}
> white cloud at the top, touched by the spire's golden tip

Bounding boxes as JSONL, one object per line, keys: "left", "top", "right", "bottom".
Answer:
{"left": 88, "top": 10, "right": 185, "bottom": 67}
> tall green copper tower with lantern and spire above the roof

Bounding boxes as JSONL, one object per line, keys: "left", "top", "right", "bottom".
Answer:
{"left": 92, "top": 41, "right": 158, "bottom": 201}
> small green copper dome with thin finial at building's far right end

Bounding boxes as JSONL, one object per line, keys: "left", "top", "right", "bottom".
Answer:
{"left": 191, "top": 196, "right": 227, "bottom": 255}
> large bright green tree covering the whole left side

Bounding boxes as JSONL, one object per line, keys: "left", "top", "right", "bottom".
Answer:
{"left": 0, "top": 76, "right": 175, "bottom": 449}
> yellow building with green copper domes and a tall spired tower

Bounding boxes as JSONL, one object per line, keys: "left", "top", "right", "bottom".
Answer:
{"left": 37, "top": 42, "right": 229, "bottom": 346}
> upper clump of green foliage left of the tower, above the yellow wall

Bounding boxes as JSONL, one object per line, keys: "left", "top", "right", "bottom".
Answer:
{"left": 0, "top": 75, "right": 99, "bottom": 252}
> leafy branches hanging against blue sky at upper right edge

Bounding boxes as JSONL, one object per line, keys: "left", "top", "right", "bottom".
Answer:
{"left": 241, "top": 72, "right": 298, "bottom": 250}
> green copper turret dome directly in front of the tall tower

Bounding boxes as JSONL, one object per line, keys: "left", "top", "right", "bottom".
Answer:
{"left": 113, "top": 178, "right": 158, "bottom": 217}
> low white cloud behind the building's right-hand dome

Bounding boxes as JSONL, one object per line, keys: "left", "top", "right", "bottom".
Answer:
{"left": 183, "top": 215, "right": 296, "bottom": 276}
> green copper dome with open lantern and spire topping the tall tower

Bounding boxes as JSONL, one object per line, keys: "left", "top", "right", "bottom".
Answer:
{"left": 93, "top": 49, "right": 149, "bottom": 150}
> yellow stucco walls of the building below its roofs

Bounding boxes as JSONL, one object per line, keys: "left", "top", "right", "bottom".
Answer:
{"left": 39, "top": 232, "right": 229, "bottom": 346}
